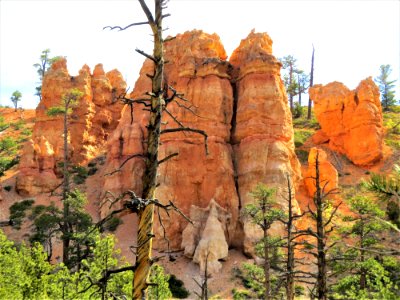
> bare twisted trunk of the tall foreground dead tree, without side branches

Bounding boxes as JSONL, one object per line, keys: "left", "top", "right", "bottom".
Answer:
{"left": 133, "top": 0, "right": 165, "bottom": 299}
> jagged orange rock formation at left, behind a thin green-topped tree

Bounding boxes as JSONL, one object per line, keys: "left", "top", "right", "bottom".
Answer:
{"left": 16, "top": 58, "right": 126, "bottom": 195}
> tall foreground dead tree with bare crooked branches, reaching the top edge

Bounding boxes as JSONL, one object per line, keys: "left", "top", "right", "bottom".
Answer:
{"left": 105, "top": 0, "right": 207, "bottom": 299}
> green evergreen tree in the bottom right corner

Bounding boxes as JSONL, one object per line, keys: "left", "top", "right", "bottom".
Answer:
{"left": 333, "top": 196, "right": 400, "bottom": 299}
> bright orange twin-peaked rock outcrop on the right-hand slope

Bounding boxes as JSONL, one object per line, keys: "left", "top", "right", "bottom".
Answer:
{"left": 309, "top": 78, "right": 383, "bottom": 166}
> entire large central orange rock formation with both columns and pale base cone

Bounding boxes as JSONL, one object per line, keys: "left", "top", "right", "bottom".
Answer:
{"left": 101, "top": 30, "right": 300, "bottom": 258}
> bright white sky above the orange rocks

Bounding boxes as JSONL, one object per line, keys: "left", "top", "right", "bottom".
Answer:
{"left": 0, "top": 0, "right": 400, "bottom": 108}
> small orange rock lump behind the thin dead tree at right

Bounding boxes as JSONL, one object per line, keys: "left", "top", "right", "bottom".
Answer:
{"left": 304, "top": 147, "right": 339, "bottom": 197}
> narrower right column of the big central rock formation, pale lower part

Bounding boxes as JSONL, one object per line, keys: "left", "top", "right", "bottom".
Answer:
{"left": 230, "top": 32, "right": 301, "bottom": 254}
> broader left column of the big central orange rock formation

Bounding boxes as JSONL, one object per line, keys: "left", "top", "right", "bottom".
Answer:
{"left": 102, "top": 31, "right": 239, "bottom": 248}
